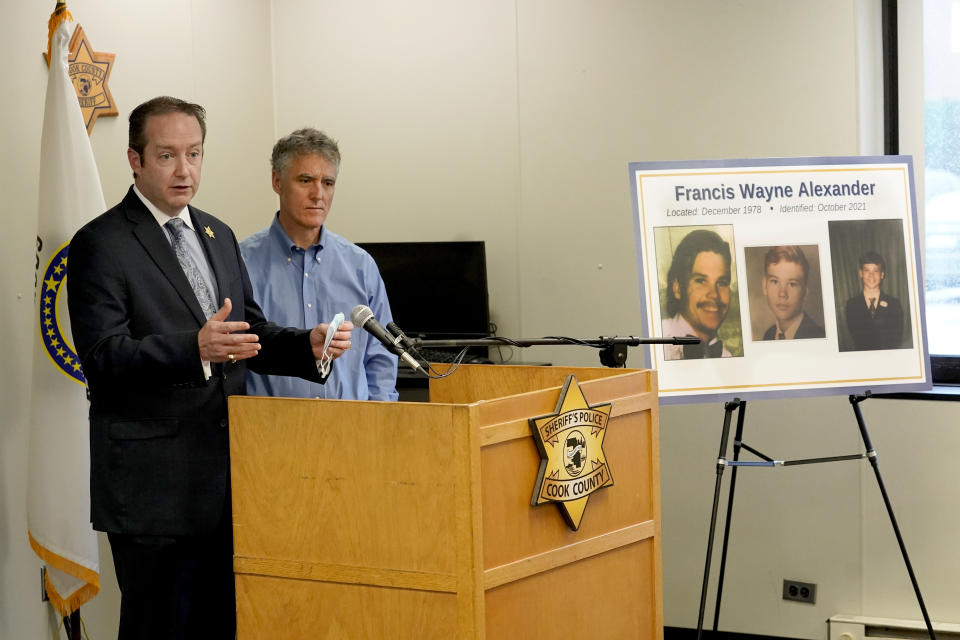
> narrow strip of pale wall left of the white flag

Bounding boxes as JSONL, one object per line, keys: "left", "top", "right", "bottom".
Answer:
{"left": 0, "top": 3, "right": 49, "bottom": 639}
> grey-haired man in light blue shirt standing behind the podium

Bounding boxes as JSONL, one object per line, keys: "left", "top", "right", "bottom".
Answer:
{"left": 240, "top": 128, "right": 397, "bottom": 400}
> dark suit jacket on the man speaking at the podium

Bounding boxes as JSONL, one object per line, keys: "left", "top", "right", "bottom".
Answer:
{"left": 67, "top": 189, "right": 320, "bottom": 535}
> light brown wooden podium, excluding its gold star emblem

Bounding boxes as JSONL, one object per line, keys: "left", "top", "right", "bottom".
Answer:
{"left": 230, "top": 365, "right": 663, "bottom": 640}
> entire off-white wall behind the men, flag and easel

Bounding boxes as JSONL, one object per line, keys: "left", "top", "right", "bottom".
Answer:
{"left": 0, "top": 0, "right": 960, "bottom": 638}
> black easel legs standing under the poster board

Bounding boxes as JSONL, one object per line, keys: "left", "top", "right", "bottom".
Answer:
{"left": 697, "top": 391, "right": 936, "bottom": 640}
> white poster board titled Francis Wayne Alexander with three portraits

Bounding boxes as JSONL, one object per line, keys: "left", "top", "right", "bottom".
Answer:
{"left": 629, "top": 156, "right": 930, "bottom": 404}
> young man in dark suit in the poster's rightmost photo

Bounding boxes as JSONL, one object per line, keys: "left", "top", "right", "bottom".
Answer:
{"left": 846, "top": 251, "right": 908, "bottom": 351}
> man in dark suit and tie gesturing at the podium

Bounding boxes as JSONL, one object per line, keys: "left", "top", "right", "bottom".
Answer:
{"left": 67, "top": 97, "right": 352, "bottom": 639}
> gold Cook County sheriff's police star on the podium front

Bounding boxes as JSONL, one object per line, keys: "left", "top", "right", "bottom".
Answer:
{"left": 530, "top": 376, "right": 613, "bottom": 531}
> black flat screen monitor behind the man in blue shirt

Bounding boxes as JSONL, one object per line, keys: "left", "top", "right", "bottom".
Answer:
{"left": 357, "top": 241, "right": 490, "bottom": 340}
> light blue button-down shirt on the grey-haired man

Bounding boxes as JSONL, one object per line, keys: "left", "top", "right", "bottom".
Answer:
{"left": 240, "top": 216, "right": 397, "bottom": 400}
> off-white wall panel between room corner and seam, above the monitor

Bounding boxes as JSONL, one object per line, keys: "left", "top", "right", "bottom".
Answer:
{"left": 266, "top": 0, "right": 521, "bottom": 335}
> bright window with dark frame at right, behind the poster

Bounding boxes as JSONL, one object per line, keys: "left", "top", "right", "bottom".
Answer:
{"left": 896, "top": 0, "right": 960, "bottom": 384}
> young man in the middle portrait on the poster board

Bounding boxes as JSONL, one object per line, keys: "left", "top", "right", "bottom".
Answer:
{"left": 762, "top": 245, "right": 826, "bottom": 340}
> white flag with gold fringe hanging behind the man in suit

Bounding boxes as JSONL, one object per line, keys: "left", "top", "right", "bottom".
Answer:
{"left": 27, "top": 7, "right": 105, "bottom": 615}
